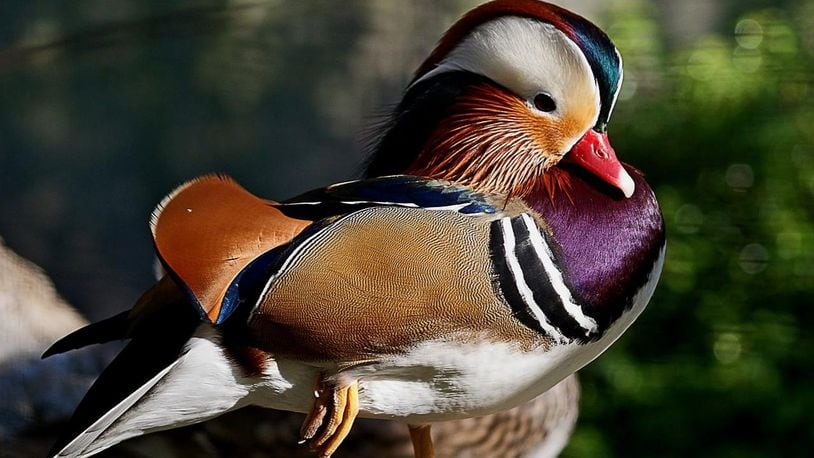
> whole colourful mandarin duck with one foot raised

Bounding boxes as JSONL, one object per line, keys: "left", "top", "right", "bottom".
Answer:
{"left": 44, "top": 0, "right": 665, "bottom": 457}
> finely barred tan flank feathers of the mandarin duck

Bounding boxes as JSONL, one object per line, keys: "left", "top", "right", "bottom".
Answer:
{"left": 250, "top": 207, "right": 545, "bottom": 364}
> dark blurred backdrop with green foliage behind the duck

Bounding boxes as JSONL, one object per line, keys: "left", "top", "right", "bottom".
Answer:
{"left": 0, "top": 0, "right": 814, "bottom": 457}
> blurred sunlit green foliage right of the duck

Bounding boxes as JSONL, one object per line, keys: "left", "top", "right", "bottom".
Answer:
{"left": 566, "top": 1, "right": 814, "bottom": 457}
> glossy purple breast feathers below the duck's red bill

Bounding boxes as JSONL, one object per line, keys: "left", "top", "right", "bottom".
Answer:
{"left": 524, "top": 167, "right": 664, "bottom": 328}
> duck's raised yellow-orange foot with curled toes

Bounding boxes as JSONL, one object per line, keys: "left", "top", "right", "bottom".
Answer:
{"left": 300, "top": 380, "right": 359, "bottom": 457}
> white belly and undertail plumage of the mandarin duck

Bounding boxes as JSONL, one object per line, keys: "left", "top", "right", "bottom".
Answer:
{"left": 62, "top": 250, "right": 664, "bottom": 457}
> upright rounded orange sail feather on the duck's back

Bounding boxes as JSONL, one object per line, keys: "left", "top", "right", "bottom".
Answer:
{"left": 152, "top": 176, "right": 311, "bottom": 321}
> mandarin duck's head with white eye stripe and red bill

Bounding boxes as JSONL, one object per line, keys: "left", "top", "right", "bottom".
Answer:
{"left": 368, "top": 0, "right": 635, "bottom": 197}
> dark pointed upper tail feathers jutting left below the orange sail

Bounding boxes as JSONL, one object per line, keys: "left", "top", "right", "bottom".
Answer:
{"left": 42, "top": 276, "right": 190, "bottom": 358}
